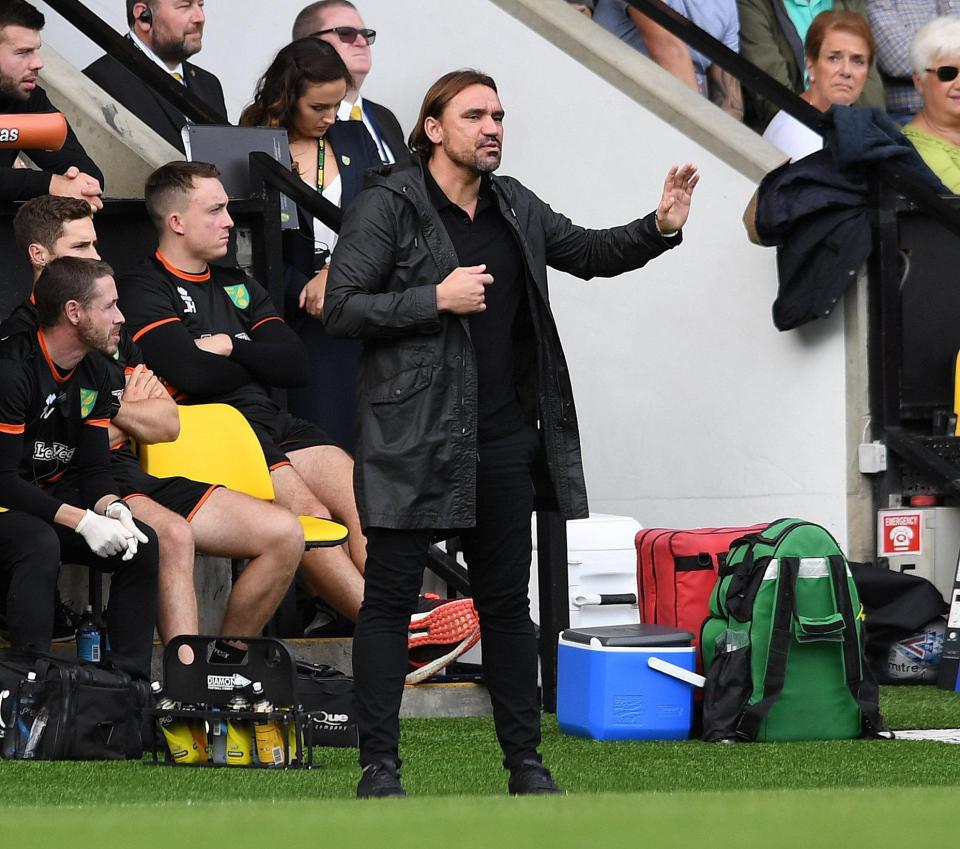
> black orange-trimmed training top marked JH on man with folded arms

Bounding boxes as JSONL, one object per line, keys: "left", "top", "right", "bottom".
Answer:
{"left": 117, "top": 251, "right": 306, "bottom": 421}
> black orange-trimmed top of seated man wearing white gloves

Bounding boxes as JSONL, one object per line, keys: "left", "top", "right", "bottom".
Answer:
{"left": 0, "top": 330, "right": 116, "bottom": 521}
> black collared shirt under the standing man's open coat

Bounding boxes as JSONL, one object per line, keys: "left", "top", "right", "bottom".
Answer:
{"left": 423, "top": 163, "right": 527, "bottom": 442}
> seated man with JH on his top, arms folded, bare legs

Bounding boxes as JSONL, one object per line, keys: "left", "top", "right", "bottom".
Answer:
{"left": 119, "top": 162, "right": 366, "bottom": 620}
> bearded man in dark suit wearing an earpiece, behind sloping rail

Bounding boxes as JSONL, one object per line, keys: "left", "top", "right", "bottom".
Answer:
{"left": 83, "top": 0, "right": 227, "bottom": 152}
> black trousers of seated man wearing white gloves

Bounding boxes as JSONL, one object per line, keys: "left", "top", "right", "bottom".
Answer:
{"left": 0, "top": 511, "right": 159, "bottom": 678}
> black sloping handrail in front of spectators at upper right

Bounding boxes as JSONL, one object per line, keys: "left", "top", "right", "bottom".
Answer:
{"left": 626, "top": 0, "right": 960, "bottom": 242}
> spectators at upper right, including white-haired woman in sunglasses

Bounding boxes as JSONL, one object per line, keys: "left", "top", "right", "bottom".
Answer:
{"left": 568, "top": 0, "right": 960, "bottom": 177}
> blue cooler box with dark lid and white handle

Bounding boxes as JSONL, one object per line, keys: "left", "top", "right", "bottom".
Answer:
{"left": 557, "top": 625, "right": 702, "bottom": 740}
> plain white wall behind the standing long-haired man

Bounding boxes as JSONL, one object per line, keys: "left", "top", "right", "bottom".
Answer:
{"left": 33, "top": 0, "right": 846, "bottom": 540}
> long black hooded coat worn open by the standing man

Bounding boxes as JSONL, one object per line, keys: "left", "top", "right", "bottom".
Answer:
{"left": 324, "top": 157, "right": 680, "bottom": 529}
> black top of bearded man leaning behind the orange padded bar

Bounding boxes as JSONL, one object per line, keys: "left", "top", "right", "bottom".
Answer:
{"left": 0, "top": 86, "right": 103, "bottom": 200}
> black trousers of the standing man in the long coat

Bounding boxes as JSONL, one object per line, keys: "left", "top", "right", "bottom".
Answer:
{"left": 353, "top": 428, "right": 540, "bottom": 769}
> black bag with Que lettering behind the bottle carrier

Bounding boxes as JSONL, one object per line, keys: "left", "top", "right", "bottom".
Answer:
{"left": 296, "top": 660, "right": 357, "bottom": 749}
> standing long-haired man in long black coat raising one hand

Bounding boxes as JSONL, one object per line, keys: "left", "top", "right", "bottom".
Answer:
{"left": 324, "top": 71, "right": 697, "bottom": 797}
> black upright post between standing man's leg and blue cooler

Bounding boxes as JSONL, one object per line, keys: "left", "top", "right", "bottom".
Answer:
{"left": 537, "top": 512, "right": 570, "bottom": 713}
